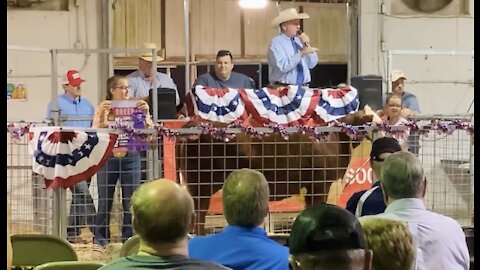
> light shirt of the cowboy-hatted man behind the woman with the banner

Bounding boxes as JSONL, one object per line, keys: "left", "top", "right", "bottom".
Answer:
{"left": 127, "top": 70, "right": 180, "bottom": 106}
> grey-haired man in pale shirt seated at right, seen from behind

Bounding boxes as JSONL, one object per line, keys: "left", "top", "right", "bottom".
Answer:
{"left": 360, "top": 151, "right": 470, "bottom": 270}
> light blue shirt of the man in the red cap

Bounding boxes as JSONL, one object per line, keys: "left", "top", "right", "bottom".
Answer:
{"left": 47, "top": 93, "right": 95, "bottom": 127}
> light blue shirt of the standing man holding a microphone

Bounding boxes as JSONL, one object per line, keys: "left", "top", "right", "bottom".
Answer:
{"left": 268, "top": 33, "right": 318, "bottom": 84}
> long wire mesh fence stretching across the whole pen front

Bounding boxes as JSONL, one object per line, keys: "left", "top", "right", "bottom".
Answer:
{"left": 7, "top": 118, "right": 474, "bottom": 260}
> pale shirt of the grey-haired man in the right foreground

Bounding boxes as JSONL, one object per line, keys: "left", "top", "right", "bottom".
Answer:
{"left": 360, "top": 198, "right": 470, "bottom": 270}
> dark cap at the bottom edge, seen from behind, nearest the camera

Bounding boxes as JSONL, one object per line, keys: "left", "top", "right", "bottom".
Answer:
{"left": 288, "top": 204, "right": 366, "bottom": 255}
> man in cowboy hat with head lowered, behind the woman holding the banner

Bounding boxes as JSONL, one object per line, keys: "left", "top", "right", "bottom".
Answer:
{"left": 127, "top": 43, "right": 180, "bottom": 106}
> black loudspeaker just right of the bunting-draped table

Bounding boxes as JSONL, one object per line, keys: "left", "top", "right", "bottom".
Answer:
{"left": 350, "top": 75, "right": 383, "bottom": 111}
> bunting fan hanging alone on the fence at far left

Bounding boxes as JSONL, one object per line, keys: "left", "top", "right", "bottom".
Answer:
{"left": 29, "top": 127, "right": 117, "bottom": 188}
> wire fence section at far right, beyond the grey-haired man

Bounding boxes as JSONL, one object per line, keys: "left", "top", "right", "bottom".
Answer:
{"left": 419, "top": 127, "right": 474, "bottom": 226}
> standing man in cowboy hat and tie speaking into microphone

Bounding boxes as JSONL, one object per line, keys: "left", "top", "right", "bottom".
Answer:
{"left": 268, "top": 8, "right": 318, "bottom": 86}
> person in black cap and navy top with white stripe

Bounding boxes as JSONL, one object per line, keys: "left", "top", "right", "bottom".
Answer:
{"left": 345, "top": 137, "right": 402, "bottom": 217}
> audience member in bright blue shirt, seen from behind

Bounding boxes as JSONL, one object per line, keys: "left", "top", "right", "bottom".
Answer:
{"left": 188, "top": 169, "right": 289, "bottom": 270}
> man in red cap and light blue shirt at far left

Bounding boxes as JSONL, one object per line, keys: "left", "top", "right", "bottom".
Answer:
{"left": 47, "top": 70, "right": 96, "bottom": 242}
